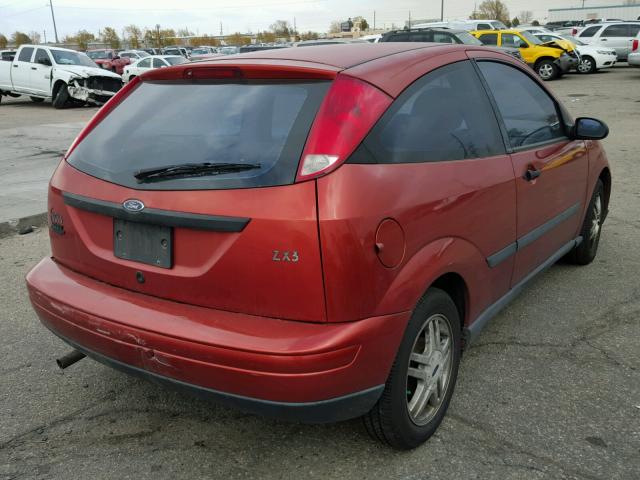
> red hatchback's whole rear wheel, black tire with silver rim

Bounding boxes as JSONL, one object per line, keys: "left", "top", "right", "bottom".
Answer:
{"left": 363, "top": 288, "right": 461, "bottom": 450}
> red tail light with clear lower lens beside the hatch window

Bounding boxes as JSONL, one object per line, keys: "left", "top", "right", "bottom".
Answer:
{"left": 296, "top": 75, "right": 392, "bottom": 182}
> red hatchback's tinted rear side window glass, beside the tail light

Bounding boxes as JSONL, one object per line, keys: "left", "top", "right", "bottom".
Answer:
{"left": 365, "top": 61, "right": 505, "bottom": 163}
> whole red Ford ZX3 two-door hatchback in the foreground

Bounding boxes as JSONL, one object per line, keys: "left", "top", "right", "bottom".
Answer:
{"left": 27, "top": 43, "right": 611, "bottom": 448}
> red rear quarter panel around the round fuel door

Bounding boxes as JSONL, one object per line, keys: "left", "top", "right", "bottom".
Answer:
{"left": 318, "top": 156, "right": 516, "bottom": 323}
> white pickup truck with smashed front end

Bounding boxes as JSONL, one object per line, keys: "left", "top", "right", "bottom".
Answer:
{"left": 0, "top": 45, "right": 122, "bottom": 108}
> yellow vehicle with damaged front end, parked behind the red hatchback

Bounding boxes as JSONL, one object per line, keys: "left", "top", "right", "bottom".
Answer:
{"left": 471, "top": 30, "right": 580, "bottom": 80}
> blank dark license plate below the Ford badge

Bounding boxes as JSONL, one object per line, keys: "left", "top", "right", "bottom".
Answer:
{"left": 113, "top": 218, "right": 173, "bottom": 268}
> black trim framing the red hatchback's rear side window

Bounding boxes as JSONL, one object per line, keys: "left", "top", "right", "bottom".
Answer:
{"left": 345, "top": 58, "right": 513, "bottom": 165}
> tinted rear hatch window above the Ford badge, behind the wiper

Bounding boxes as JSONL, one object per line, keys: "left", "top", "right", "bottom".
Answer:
{"left": 67, "top": 81, "right": 330, "bottom": 190}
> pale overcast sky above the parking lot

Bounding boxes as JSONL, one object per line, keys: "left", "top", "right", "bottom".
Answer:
{"left": 0, "top": 0, "right": 622, "bottom": 39}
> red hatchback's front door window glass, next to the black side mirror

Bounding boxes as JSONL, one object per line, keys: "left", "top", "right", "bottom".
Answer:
{"left": 478, "top": 62, "right": 565, "bottom": 148}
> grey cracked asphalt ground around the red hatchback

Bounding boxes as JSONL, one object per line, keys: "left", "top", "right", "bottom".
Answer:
{"left": 0, "top": 67, "right": 640, "bottom": 480}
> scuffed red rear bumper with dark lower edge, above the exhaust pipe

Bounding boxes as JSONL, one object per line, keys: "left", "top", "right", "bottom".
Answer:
{"left": 27, "top": 259, "right": 410, "bottom": 422}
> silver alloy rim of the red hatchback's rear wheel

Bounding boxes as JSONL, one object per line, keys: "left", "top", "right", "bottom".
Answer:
{"left": 407, "top": 314, "right": 453, "bottom": 426}
